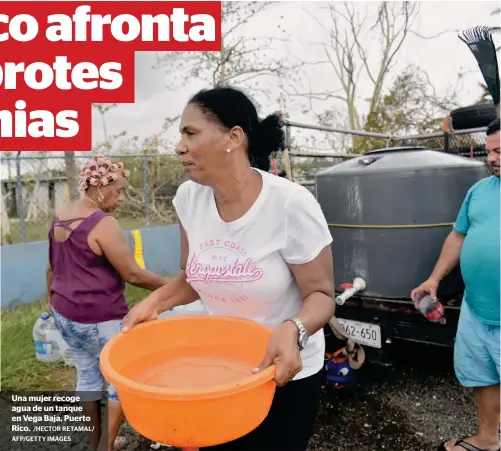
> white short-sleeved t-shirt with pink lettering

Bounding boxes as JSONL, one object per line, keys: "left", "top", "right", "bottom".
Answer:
{"left": 173, "top": 169, "right": 332, "bottom": 379}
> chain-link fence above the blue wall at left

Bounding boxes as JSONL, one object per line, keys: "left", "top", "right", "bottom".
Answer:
{"left": 1, "top": 152, "right": 184, "bottom": 245}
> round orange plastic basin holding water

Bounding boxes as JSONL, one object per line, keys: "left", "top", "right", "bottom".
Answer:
{"left": 100, "top": 316, "right": 276, "bottom": 448}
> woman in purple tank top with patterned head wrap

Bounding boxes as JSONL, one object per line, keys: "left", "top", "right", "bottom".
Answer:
{"left": 47, "top": 155, "right": 167, "bottom": 451}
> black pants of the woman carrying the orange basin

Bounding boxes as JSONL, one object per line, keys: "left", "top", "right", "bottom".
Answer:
{"left": 200, "top": 371, "right": 322, "bottom": 451}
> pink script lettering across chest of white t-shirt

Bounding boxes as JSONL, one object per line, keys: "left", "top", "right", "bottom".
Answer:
{"left": 186, "top": 254, "right": 263, "bottom": 283}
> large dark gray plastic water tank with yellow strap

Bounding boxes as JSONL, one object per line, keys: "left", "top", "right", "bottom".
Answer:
{"left": 315, "top": 147, "right": 489, "bottom": 299}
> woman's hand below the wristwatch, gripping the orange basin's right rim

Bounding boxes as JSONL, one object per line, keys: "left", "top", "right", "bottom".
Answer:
{"left": 252, "top": 321, "right": 303, "bottom": 387}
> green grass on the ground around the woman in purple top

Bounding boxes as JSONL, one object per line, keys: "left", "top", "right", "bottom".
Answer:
{"left": 1, "top": 286, "right": 149, "bottom": 391}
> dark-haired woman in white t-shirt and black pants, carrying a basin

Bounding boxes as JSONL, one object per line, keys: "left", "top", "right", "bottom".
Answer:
{"left": 123, "top": 87, "right": 335, "bottom": 451}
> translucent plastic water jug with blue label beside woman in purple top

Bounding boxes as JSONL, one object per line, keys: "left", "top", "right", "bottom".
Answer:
{"left": 33, "top": 312, "right": 74, "bottom": 366}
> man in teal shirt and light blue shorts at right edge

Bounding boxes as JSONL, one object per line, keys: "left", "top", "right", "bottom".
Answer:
{"left": 411, "top": 118, "right": 501, "bottom": 451}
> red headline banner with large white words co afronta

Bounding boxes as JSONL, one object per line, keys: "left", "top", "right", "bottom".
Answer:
{"left": 0, "top": 1, "right": 221, "bottom": 151}
